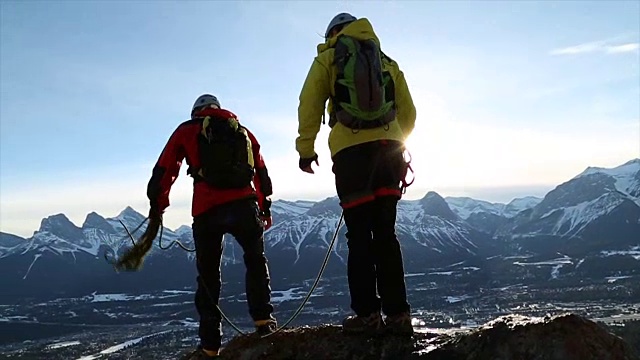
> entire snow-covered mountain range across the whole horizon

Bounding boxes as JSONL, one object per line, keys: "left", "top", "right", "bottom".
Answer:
{"left": 0, "top": 159, "right": 640, "bottom": 297}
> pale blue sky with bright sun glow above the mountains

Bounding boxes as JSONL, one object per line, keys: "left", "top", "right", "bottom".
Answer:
{"left": 0, "top": 0, "right": 640, "bottom": 236}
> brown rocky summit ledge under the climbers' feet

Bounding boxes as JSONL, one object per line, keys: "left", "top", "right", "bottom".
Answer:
{"left": 214, "top": 314, "right": 640, "bottom": 360}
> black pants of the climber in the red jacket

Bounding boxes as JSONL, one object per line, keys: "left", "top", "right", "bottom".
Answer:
{"left": 193, "top": 199, "right": 273, "bottom": 350}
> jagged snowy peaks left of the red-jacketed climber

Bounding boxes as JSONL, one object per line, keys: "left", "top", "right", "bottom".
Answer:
{"left": 0, "top": 207, "right": 200, "bottom": 298}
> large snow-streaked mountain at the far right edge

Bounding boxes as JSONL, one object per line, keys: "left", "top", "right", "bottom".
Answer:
{"left": 496, "top": 159, "right": 640, "bottom": 276}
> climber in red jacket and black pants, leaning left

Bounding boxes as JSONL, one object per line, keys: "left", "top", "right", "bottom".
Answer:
{"left": 147, "top": 94, "right": 276, "bottom": 359}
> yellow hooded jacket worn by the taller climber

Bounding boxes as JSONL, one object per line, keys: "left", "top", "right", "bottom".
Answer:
{"left": 296, "top": 18, "right": 416, "bottom": 158}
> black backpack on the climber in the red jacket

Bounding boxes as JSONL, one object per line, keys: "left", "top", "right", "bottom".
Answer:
{"left": 197, "top": 116, "right": 255, "bottom": 189}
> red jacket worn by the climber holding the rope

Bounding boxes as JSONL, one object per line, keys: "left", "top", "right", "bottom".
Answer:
{"left": 147, "top": 108, "right": 273, "bottom": 216}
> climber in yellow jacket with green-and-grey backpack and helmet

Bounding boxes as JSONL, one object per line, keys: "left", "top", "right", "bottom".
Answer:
{"left": 296, "top": 13, "right": 416, "bottom": 335}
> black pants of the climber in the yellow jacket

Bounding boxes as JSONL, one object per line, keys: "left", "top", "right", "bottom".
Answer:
{"left": 333, "top": 142, "right": 410, "bottom": 316}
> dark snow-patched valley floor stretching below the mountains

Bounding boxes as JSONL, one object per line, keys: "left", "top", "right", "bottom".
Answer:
{"left": 0, "top": 269, "right": 640, "bottom": 360}
